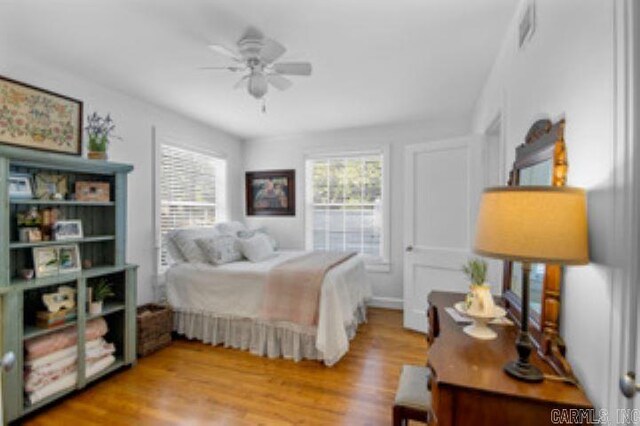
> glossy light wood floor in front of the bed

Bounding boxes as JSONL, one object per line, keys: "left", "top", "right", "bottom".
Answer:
{"left": 25, "top": 309, "right": 426, "bottom": 426}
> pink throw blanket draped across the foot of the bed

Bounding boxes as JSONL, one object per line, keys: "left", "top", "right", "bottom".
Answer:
{"left": 262, "top": 251, "right": 356, "bottom": 325}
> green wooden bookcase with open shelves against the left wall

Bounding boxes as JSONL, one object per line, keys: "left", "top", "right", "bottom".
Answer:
{"left": 0, "top": 145, "right": 137, "bottom": 422}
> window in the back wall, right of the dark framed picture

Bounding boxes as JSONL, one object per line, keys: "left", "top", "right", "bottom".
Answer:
{"left": 306, "top": 147, "right": 388, "bottom": 263}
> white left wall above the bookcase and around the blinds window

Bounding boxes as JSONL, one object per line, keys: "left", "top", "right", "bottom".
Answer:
{"left": 0, "top": 50, "right": 243, "bottom": 304}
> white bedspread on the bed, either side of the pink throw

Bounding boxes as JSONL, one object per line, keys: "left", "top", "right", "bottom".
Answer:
{"left": 167, "top": 251, "right": 371, "bottom": 365}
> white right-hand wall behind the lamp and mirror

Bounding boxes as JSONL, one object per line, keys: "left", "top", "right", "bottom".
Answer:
{"left": 473, "top": 0, "right": 615, "bottom": 407}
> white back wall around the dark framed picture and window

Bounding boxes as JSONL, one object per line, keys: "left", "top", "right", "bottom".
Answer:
{"left": 244, "top": 117, "right": 469, "bottom": 308}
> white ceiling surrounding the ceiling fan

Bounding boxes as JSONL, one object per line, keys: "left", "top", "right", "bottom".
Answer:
{"left": 0, "top": 0, "right": 518, "bottom": 138}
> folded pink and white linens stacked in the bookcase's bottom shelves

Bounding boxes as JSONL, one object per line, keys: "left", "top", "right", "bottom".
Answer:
{"left": 24, "top": 318, "right": 115, "bottom": 404}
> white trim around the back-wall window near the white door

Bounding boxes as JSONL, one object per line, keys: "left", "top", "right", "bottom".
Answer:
{"left": 303, "top": 144, "right": 391, "bottom": 272}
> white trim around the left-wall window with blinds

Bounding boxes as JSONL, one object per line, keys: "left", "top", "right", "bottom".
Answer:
{"left": 151, "top": 126, "right": 229, "bottom": 276}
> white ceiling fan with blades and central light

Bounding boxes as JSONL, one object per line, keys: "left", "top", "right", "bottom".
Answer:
{"left": 201, "top": 27, "right": 312, "bottom": 99}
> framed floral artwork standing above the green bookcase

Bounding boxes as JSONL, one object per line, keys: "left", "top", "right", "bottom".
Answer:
{"left": 0, "top": 76, "right": 82, "bottom": 155}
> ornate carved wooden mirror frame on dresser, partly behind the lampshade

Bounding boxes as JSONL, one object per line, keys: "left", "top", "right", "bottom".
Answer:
{"left": 503, "top": 120, "right": 572, "bottom": 375}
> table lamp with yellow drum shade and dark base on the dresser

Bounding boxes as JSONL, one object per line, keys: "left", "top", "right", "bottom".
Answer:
{"left": 474, "top": 186, "right": 589, "bottom": 382}
